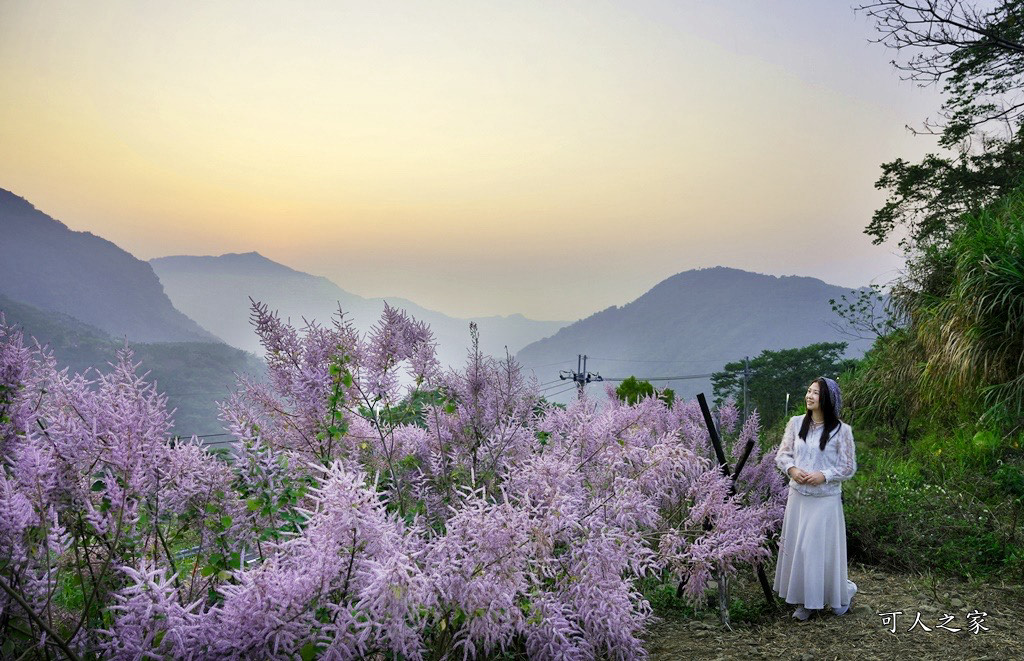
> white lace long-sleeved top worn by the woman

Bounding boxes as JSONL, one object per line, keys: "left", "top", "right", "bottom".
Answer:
{"left": 775, "top": 415, "right": 857, "bottom": 496}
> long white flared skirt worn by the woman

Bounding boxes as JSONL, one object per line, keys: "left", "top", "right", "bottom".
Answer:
{"left": 774, "top": 486, "right": 851, "bottom": 609}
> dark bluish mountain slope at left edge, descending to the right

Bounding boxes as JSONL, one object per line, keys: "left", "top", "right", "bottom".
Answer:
{"left": 0, "top": 188, "right": 220, "bottom": 342}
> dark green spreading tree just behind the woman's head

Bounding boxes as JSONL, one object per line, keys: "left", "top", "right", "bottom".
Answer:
{"left": 711, "top": 342, "right": 856, "bottom": 428}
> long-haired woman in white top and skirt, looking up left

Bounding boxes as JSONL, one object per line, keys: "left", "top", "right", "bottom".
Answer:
{"left": 774, "top": 377, "right": 857, "bottom": 620}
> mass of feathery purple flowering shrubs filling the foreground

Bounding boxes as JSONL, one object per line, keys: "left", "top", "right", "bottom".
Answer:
{"left": 0, "top": 303, "right": 784, "bottom": 659}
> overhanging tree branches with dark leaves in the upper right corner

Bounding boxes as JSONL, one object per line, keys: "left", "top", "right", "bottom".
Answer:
{"left": 857, "top": 0, "right": 1024, "bottom": 253}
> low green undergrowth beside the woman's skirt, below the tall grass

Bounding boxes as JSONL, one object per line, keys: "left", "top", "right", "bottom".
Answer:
{"left": 844, "top": 430, "right": 1024, "bottom": 576}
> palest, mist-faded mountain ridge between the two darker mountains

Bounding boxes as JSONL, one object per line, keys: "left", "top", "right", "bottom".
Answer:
{"left": 150, "top": 252, "right": 566, "bottom": 366}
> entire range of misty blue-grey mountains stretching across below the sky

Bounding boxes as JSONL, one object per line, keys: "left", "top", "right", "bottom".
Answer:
{"left": 0, "top": 184, "right": 868, "bottom": 433}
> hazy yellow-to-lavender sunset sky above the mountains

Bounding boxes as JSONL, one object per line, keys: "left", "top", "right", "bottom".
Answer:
{"left": 0, "top": 0, "right": 939, "bottom": 319}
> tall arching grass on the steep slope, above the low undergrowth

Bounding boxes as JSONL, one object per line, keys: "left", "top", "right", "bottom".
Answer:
{"left": 846, "top": 188, "right": 1024, "bottom": 435}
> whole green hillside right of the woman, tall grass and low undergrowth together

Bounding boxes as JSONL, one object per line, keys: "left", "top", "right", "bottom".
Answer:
{"left": 843, "top": 189, "right": 1024, "bottom": 577}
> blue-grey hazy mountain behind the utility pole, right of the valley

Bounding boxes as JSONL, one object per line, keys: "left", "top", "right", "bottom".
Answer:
{"left": 516, "top": 266, "right": 870, "bottom": 396}
